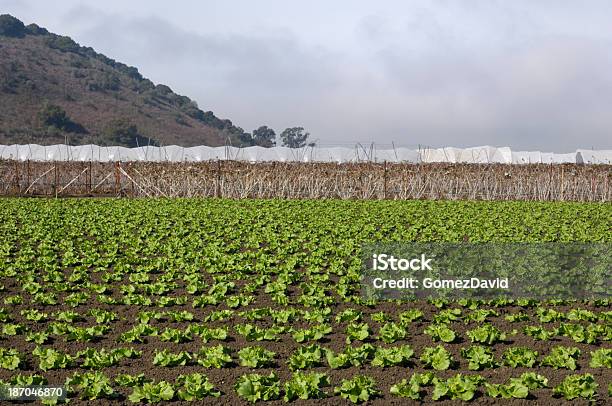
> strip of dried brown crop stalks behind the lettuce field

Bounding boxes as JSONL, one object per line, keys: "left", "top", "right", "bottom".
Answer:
{"left": 0, "top": 161, "right": 612, "bottom": 202}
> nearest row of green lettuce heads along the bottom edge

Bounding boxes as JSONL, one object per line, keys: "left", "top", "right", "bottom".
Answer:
{"left": 1, "top": 371, "right": 612, "bottom": 404}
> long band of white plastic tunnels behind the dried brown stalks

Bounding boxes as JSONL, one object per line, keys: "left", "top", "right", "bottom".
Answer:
{"left": 0, "top": 144, "right": 612, "bottom": 164}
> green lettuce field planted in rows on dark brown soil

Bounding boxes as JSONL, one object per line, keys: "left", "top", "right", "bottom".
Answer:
{"left": 0, "top": 199, "right": 612, "bottom": 405}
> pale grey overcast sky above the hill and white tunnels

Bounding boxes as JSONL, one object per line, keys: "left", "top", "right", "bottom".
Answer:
{"left": 0, "top": 0, "right": 612, "bottom": 152}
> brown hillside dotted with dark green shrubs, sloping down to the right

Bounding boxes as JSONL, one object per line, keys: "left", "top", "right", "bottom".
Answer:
{"left": 0, "top": 15, "right": 250, "bottom": 146}
